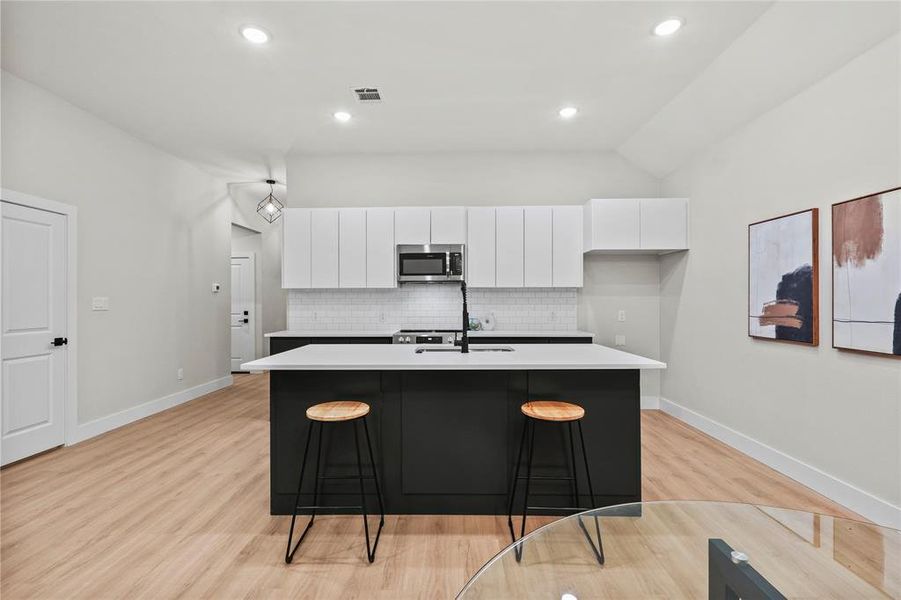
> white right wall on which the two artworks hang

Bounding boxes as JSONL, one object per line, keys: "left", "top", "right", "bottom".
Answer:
{"left": 661, "top": 36, "right": 901, "bottom": 523}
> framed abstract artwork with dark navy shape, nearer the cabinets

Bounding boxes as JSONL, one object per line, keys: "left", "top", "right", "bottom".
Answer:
{"left": 748, "top": 208, "right": 820, "bottom": 346}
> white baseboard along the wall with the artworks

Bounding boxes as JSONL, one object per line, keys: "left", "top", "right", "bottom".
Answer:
{"left": 642, "top": 397, "right": 901, "bottom": 529}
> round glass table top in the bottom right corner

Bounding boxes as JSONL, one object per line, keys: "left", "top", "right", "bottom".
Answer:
{"left": 457, "top": 501, "right": 901, "bottom": 600}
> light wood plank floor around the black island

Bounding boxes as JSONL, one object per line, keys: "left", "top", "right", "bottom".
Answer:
{"left": 0, "top": 375, "right": 856, "bottom": 600}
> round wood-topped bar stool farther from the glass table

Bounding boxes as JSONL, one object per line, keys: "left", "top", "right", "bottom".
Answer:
{"left": 285, "top": 401, "right": 385, "bottom": 563}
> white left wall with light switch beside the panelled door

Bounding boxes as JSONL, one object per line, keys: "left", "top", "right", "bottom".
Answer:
{"left": 0, "top": 72, "right": 230, "bottom": 431}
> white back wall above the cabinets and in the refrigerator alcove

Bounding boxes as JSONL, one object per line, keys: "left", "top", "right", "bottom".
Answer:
{"left": 287, "top": 152, "right": 660, "bottom": 396}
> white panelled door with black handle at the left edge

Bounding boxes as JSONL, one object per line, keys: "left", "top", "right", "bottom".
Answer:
{"left": 0, "top": 202, "right": 69, "bottom": 464}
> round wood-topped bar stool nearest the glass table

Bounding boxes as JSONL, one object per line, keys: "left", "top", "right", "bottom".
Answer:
{"left": 507, "top": 400, "right": 604, "bottom": 565}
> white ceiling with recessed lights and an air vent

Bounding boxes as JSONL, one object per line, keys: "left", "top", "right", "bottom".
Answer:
{"left": 0, "top": 1, "right": 898, "bottom": 182}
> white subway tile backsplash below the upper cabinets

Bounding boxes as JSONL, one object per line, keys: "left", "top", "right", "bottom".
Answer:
{"left": 288, "top": 284, "right": 578, "bottom": 331}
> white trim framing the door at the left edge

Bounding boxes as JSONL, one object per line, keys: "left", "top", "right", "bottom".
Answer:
{"left": 0, "top": 188, "right": 79, "bottom": 446}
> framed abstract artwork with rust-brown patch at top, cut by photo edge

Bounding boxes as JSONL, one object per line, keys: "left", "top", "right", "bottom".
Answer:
{"left": 832, "top": 188, "right": 901, "bottom": 357}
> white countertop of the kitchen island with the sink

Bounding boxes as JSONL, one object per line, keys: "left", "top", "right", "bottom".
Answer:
{"left": 241, "top": 344, "right": 666, "bottom": 372}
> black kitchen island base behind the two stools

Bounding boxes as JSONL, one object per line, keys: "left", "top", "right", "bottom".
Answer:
{"left": 270, "top": 370, "right": 641, "bottom": 514}
